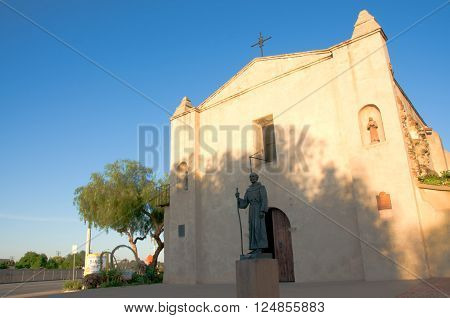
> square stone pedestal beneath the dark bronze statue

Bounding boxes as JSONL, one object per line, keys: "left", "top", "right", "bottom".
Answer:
{"left": 236, "top": 258, "right": 280, "bottom": 298}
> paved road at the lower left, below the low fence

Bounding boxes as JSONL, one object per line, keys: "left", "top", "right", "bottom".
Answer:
{"left": 0, "top": 280, "right": 64, "bottom": 297}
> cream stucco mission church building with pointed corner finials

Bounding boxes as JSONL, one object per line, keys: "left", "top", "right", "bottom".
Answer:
{"left": 164, "top": 10, "right": 450, "bottom": 284}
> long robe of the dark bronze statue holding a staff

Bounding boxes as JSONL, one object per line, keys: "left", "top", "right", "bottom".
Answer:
{"left": 239, "top": 182, "right": 269, "bottom": 250}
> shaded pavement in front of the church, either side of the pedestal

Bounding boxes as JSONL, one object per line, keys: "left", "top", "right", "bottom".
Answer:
{"left": 48, "top": 280, "right": 444, "bottom": 298}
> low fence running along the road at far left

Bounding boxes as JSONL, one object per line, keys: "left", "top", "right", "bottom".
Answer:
{"left": 0, "top": 269, "right": 83, "bottom": 284}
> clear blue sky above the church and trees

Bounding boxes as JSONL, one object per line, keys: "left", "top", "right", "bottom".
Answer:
{"left": 0, "top": 0, "right": 450, "bottom": 259}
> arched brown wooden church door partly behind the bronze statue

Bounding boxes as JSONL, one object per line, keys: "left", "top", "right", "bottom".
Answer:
{"left": 266, "top": 208, "right": 295, "bottom": 282}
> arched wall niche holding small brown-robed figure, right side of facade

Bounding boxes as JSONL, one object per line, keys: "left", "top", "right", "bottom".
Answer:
{"left": 358, "top": 105, "right": 386, "bottom": 145}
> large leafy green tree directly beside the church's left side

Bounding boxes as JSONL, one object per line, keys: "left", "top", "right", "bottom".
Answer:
{"left": 74, "top": 160, "right": 164, "bottom": 265}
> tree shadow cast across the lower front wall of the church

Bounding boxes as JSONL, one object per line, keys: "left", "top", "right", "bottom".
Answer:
{"left": 166, "top": 132, "right": 446, "bottom": 283}
